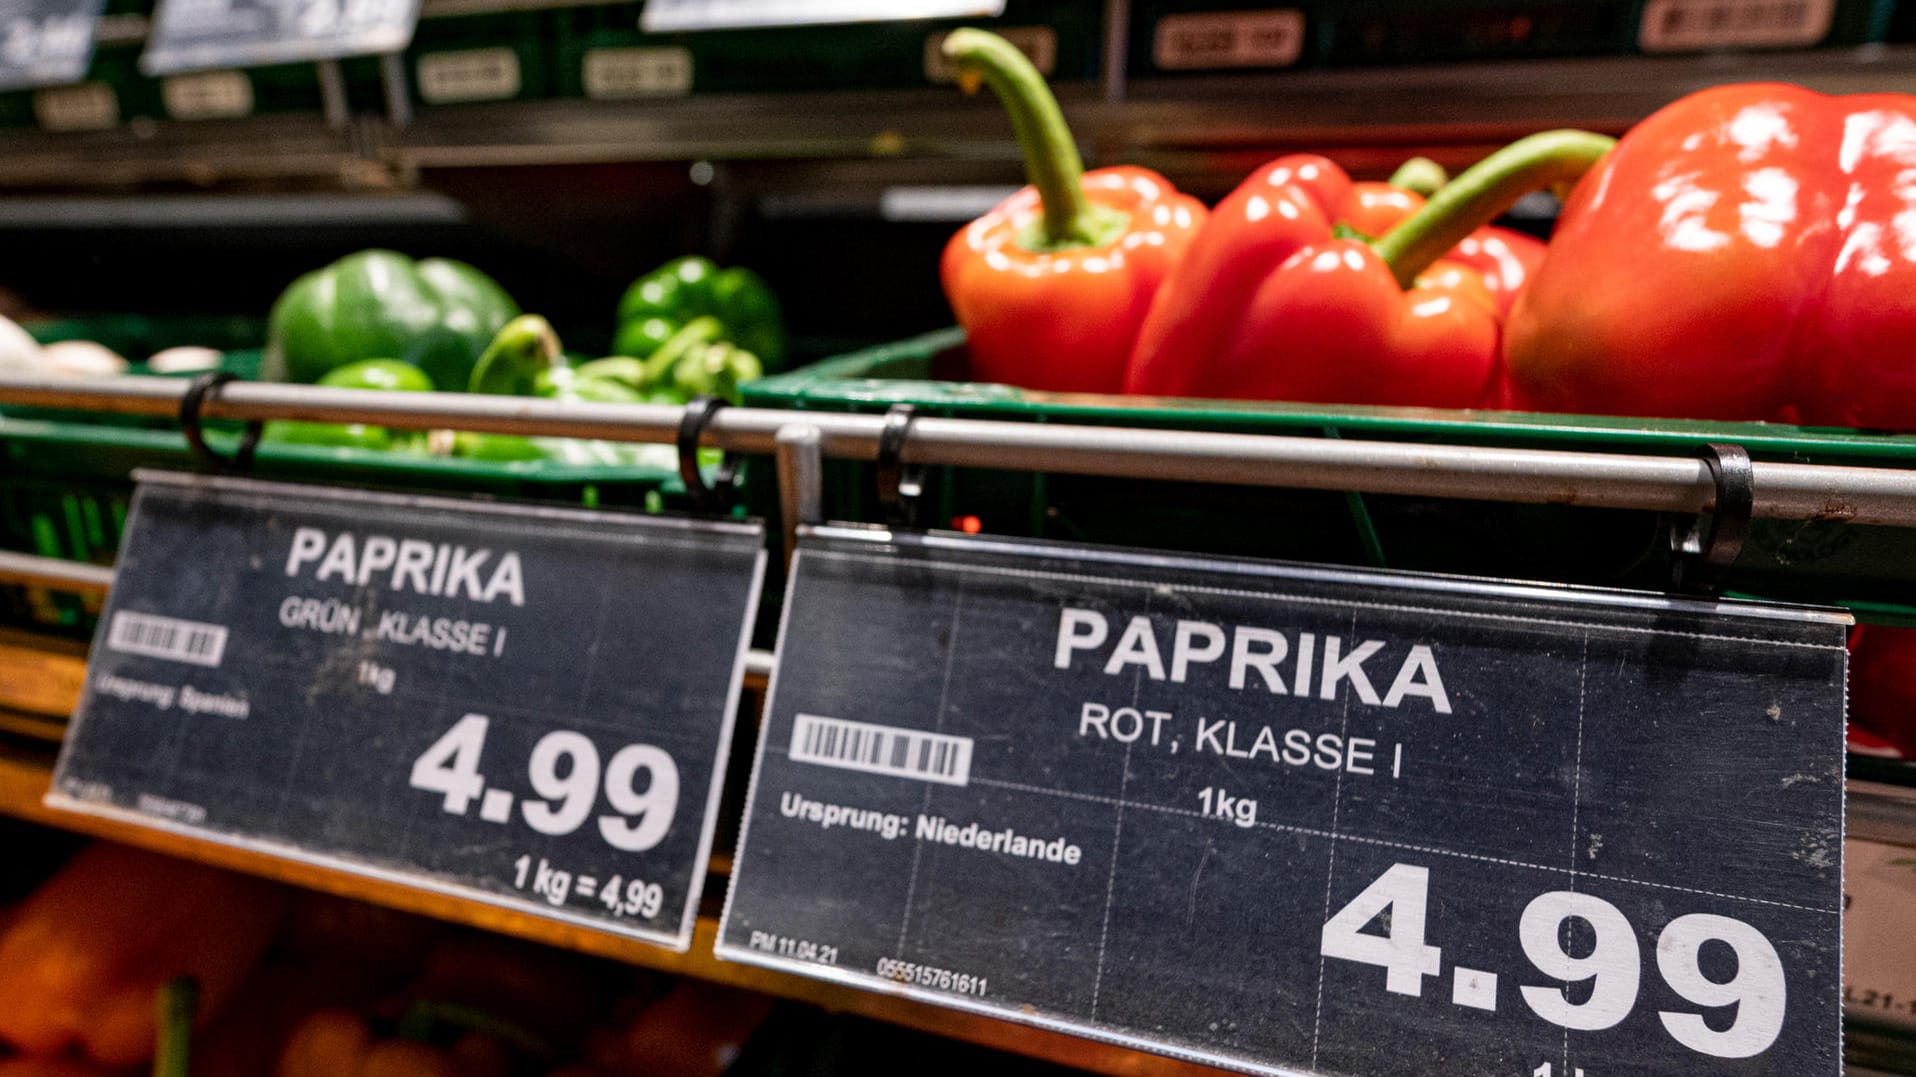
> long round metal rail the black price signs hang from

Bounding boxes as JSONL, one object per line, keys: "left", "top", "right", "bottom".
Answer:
{"left": 11, "top": 378, "right": 1916, "bottom": 527}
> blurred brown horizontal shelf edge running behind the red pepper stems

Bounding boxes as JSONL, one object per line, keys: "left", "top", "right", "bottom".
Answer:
{"left": 0, "top": 46, "right": 1916, "bottom": 190}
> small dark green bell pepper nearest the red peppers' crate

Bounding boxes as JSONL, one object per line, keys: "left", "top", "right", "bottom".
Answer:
{"left": 613, "top": 257, "right": 786, "bottom": 370}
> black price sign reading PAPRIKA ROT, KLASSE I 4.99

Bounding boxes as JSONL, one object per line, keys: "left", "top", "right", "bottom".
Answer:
{"left": 719, "top": 529, "right": 1849, "bottom": 1077}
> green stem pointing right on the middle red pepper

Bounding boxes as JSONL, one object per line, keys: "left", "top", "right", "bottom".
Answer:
{"left": 1376, "top": 130, "right": 1617, "bottom": 287}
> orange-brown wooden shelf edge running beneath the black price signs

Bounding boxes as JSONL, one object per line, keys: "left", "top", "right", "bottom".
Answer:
{"left": 0, "top": 751, "right": 1224, "bottom": 1077}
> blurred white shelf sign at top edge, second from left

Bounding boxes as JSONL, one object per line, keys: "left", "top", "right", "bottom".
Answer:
{"left": 140, "top": 0, "right": 420, "bottom": 75}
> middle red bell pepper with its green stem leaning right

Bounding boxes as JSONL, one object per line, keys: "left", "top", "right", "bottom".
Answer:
{"left": 1125, "top": 130, "right": 1611, "bottom": 408}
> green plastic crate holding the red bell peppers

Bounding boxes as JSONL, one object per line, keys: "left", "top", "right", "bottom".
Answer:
{"left": 745, "top": 330, "right": 1916, "bottom": 623}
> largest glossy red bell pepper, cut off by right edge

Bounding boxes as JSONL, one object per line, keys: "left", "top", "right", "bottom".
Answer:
{"left": 1506, "top": 84, "right": 1916, "bottom": 429}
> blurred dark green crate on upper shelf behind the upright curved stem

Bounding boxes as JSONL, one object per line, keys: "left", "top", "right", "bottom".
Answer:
{"left": 556, "top": 0, "right": 1104, "bottom": 100}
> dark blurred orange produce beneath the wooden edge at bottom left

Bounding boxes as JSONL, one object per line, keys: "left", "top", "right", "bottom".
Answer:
{"left": 0, "top": 843, "right": 772, "bottom": 1077}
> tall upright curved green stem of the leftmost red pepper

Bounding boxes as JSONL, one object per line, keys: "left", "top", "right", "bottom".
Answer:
{"left": 945, "top": 29, "right": 1106, "bottom": 247}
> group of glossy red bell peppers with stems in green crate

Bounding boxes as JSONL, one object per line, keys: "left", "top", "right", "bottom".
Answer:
{"left": 943, "top": 33, "right": 1916, "bottom": 440}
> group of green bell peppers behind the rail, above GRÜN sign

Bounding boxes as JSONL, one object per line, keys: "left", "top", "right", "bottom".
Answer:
{"left": 249, "top": 251, "right": 786, "bottom": 468}
